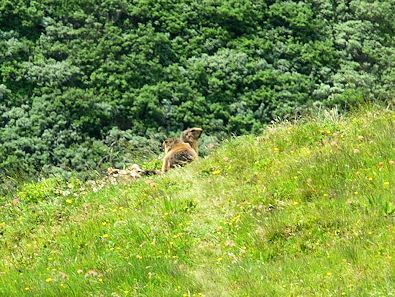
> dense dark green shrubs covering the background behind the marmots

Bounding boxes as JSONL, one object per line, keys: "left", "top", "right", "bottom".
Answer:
{"left": 0, "top": 0, "right": 395, "bottom": 175}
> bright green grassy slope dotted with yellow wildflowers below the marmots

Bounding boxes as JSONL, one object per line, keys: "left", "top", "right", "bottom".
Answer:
{"left": 0, "top": 109, "right": 395, "bottom": 296}
